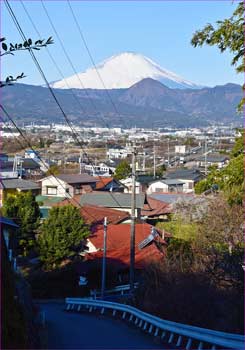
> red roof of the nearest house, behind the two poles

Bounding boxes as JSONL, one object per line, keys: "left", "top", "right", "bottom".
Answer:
{"left": 87, "top": 224, "right": 165, "bottom": 269}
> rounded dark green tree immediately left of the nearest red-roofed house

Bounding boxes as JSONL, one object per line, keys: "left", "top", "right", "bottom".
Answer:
{"left": 38, "top": 205, "right": 90, "bottom": 269}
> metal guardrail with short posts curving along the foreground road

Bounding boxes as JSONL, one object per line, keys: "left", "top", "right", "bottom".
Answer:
{"left": 66, "top": 298, "right": 245, "bottom": 350}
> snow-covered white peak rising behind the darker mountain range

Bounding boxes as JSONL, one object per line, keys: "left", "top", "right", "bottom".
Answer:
{"left": 51, "top": 52, "right": 200, "bottom": 89}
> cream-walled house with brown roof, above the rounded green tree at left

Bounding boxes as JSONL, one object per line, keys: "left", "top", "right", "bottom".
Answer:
{"left": 40, "top": 173, "right": 97, "bottom": 198}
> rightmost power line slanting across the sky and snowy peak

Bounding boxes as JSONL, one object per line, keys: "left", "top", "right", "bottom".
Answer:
{"left": 67, "top": 0, "right": 127, "bottom": 128}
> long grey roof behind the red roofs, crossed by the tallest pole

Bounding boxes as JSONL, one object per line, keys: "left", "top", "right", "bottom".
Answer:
{"left": 80, "top": 192, "right": 145, "bottom": 208}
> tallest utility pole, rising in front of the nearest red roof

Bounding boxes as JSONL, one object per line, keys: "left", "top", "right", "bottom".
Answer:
{"left": 129, "top": 142, "right": 136, "bottom": 294}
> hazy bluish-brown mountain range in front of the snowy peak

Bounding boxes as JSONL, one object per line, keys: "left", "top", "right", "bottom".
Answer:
{"left": 1, "top": 78, "right": 242, "bottom": 128}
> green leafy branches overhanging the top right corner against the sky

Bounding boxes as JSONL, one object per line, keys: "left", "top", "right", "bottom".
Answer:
{"left": 191, "top": 1, "right": 245, "bottom": 110}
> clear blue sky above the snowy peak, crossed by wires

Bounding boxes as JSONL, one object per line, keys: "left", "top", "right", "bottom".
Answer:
{"left": 1, "top": 0, "right": 243, "bottom": 86}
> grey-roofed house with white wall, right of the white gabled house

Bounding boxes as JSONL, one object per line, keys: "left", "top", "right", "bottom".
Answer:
{"left": 165, "top": 168, "right": 203, "bottom": 193}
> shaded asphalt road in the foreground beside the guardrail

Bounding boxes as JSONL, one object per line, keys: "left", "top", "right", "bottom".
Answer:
{"left": 39, "top": 303, "right": 166, "bottom": 349}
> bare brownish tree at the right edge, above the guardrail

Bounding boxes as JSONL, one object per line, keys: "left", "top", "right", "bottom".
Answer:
{"left": 193, "top": 196, "right": 244, "bottom": 288}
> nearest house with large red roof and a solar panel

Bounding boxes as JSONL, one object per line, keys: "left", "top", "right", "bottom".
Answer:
{"left": 81, "top": 223, "right": 166, "bottom": 282}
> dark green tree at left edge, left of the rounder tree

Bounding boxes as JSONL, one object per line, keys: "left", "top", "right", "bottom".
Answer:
{"left": 3, "top": 192, "right": 40, "bottom": 255}
